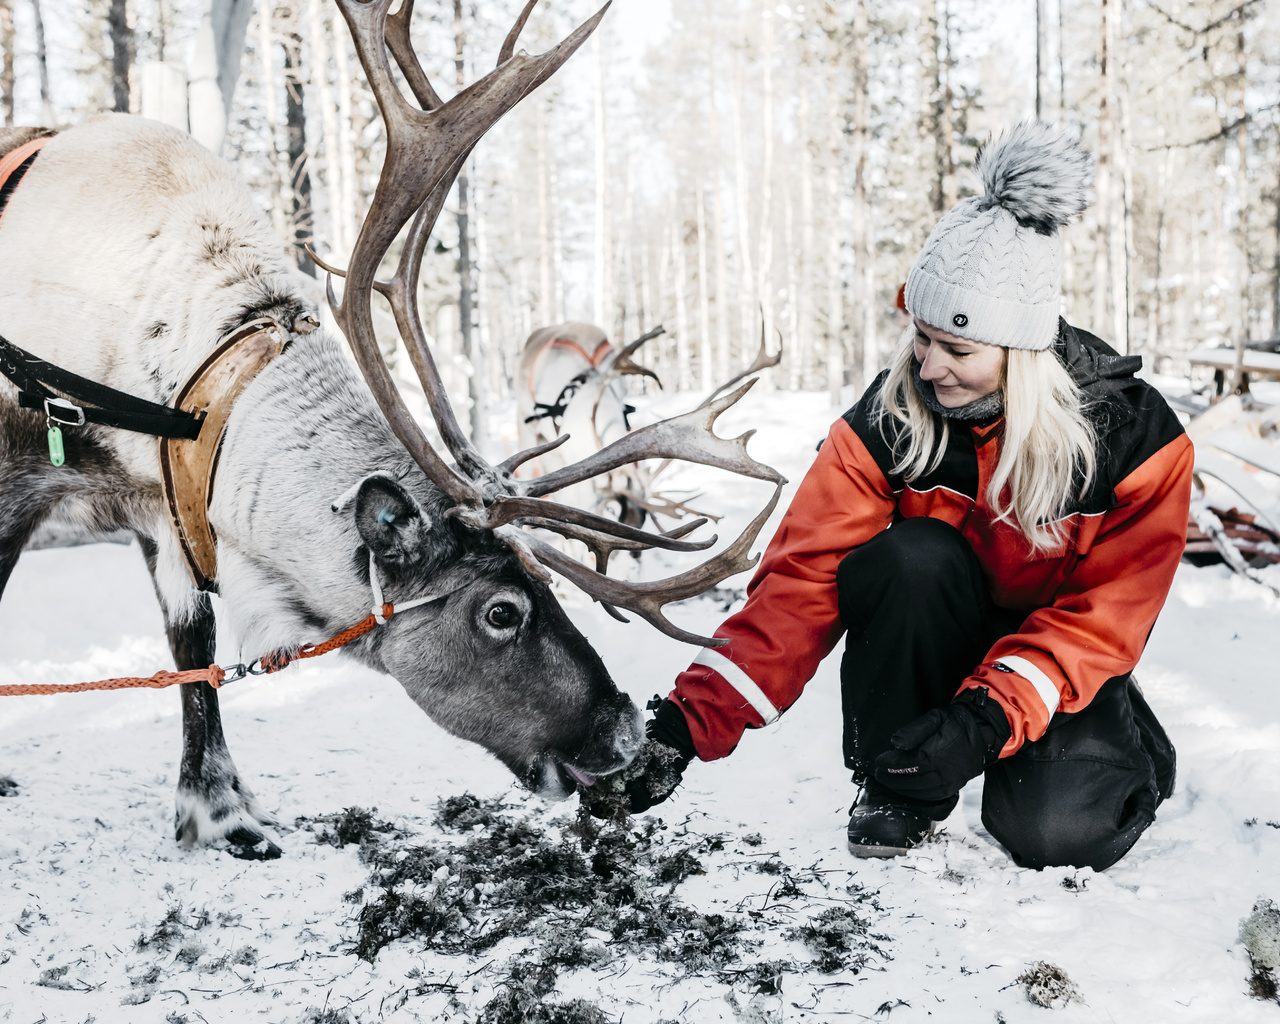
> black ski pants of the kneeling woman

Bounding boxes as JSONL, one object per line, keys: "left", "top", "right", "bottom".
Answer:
{"left": 836, "top": 518, "right": 1175, "bottom": 870}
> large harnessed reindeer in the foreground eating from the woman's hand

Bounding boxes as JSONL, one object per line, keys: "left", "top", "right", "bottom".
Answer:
{"left": 0, "top": 0, "right": 782, "bottom": 859}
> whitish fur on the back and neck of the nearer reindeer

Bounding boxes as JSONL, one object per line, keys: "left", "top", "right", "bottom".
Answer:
{"left": 0, "top": 114, "right": 394, "bottom": 658}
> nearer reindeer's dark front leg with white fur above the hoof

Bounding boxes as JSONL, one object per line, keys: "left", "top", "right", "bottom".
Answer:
{"left": 140, "top": 538, "right": 280, "bottom": 860}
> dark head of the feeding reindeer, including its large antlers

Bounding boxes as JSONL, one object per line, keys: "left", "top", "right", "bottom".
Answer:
{"left": 317, "top": 0, "right": 786, "bottom": 796}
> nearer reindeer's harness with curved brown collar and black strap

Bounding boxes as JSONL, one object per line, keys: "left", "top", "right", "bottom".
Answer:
{"left": 0, "top": 137, "right": 319, "bottom": 590}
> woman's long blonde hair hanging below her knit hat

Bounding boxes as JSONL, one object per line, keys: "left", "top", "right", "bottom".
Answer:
{"left": 874, "top": 326, "right": 1098, "bottom": 554}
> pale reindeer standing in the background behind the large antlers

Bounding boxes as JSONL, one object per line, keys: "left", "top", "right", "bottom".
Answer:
{"left": 516, "top": 321, "right": 781, "bottom": 535}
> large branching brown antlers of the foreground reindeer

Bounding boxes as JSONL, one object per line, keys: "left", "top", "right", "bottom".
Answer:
{"left": 325, "top": 0, "right": 786, "bottom": 645}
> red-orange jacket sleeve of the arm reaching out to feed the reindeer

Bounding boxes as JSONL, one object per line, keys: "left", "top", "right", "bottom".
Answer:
{"left": 671, "top": 420, "right": 897, "bottom": 760}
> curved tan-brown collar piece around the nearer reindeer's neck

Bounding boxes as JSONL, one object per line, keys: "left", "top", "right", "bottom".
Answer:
{"left": 160, "top": 317, "right": 289, "bottom": 590}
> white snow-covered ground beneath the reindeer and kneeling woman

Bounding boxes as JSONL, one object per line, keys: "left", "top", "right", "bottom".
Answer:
{"left": 0, "top": 392, "right": 1280, "bottom": 1024}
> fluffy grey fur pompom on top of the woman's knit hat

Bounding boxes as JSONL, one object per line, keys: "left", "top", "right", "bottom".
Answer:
{"left": 977, "top": 120, "right": 1093, "bottom": 234}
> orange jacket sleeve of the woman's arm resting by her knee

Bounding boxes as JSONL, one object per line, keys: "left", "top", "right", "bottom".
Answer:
{"left": 960, "top": 434, "right": 1194, "bottom": 756}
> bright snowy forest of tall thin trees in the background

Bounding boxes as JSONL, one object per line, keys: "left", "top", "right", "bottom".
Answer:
{"left": 0, "top": 0, "right": 1280, "bottom": 414}
